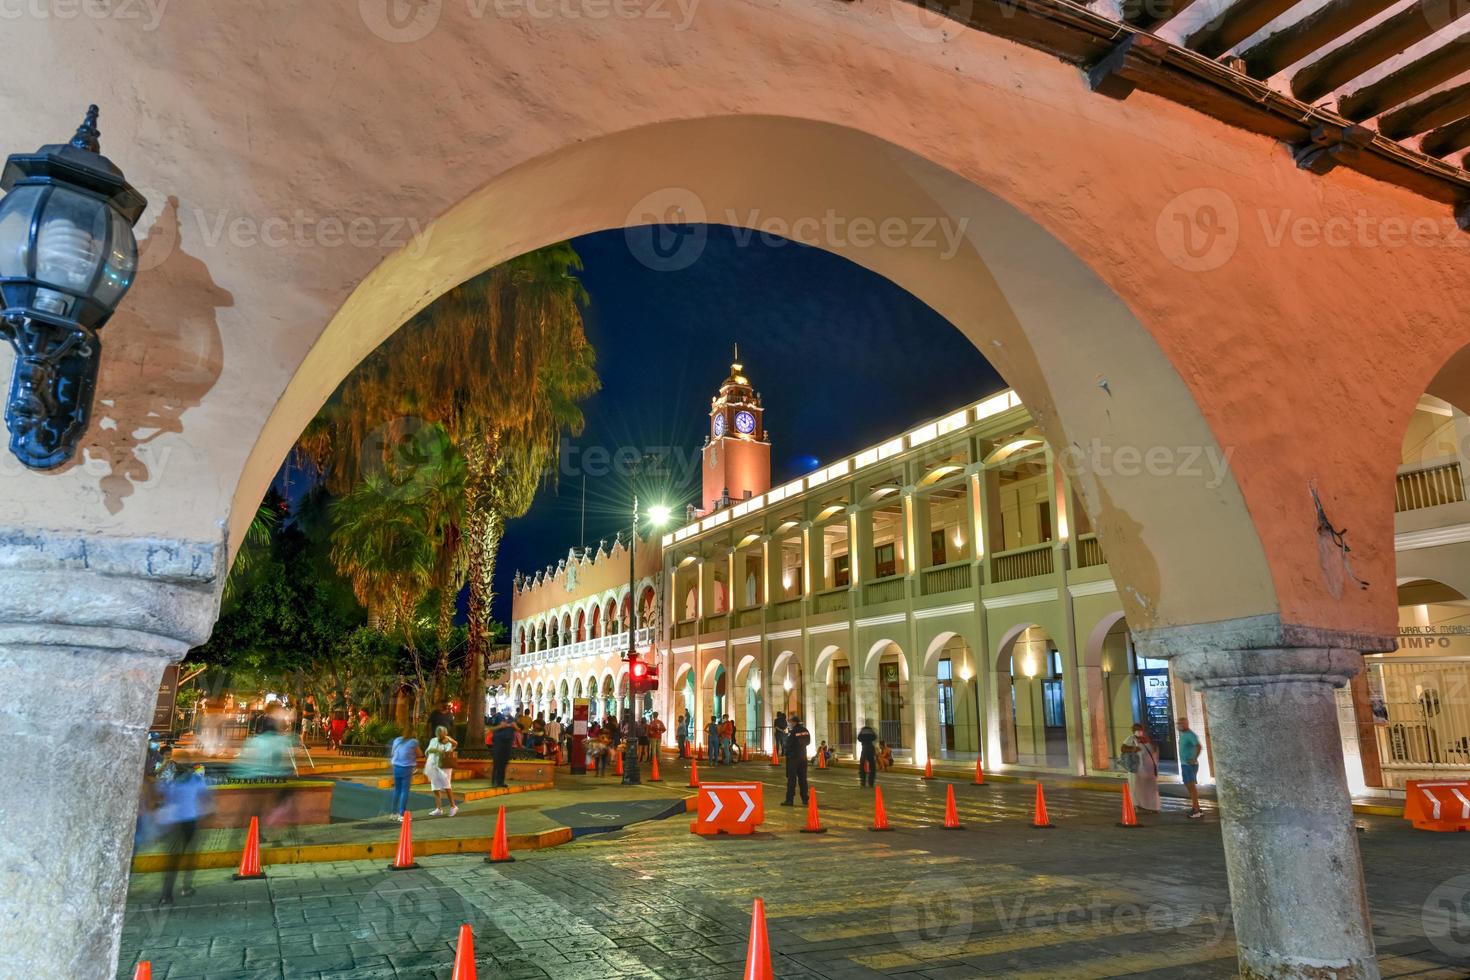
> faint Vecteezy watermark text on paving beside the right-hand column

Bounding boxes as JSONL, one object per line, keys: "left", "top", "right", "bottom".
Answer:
{"left": 991, "top": 895, "right": 1232, "bottom": 945}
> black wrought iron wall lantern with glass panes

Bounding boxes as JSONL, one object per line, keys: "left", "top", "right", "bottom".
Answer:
{"left": 0, "top": 106, "right": 148, "bottom": 470}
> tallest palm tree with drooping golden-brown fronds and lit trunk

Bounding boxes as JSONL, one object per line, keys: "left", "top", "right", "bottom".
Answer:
{"left": 300, "top": 242, "right": 600, "bottom": 742}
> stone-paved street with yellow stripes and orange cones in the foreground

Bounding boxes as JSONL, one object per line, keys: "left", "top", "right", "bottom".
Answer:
{"left": 118, "top": 765, "right": 1470, "bottom": 980}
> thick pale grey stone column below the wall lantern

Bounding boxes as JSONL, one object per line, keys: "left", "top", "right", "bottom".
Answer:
{"left": 0, "top": 530, "right": 225, "bottom": 979}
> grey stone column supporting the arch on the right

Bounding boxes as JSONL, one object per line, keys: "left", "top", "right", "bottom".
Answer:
{"left": 1141, "top": 617, "right": 1391, "bottom": 980}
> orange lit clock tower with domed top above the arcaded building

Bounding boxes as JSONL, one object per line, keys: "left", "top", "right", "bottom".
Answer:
{"left": 700, "top": 345, "right": 770, "bottom": 514}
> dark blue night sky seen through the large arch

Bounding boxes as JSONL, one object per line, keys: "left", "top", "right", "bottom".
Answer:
{"left": 494, "top": 225, "right": 1003, "bottom": 623}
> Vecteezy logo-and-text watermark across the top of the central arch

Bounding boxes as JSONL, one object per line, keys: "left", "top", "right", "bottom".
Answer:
{"left": 623, "top": 187, "right": 970, "bottom": 272}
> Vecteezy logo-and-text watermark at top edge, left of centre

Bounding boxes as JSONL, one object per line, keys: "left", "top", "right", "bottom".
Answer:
{"left": 357, "top": 0, "right": 701, "bottom": 44}
